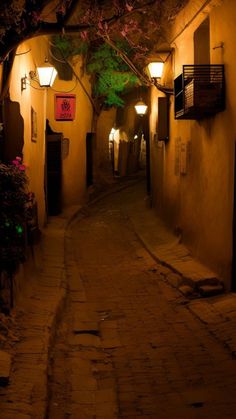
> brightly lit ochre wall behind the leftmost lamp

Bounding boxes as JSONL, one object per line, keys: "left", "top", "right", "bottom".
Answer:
{"left": 10, "top": 37, "right": 47, "bottom": 227}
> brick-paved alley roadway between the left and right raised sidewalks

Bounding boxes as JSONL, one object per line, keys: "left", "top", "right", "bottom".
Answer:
{"left": 45, "top": 181, "right": 236, "bottom": 419}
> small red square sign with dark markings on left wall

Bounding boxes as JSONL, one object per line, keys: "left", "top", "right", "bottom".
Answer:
{"left": 55, "top": 93, "right": 76, "bottom": 121}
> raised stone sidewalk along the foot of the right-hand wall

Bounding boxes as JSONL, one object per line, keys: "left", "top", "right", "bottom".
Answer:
{"left": 109, "top": 181, "right": 224, "bottom": 296}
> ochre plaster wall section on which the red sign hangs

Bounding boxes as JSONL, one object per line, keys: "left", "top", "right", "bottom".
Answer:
{"left": 47, "top": 57, "right": 93, "bottom": 206}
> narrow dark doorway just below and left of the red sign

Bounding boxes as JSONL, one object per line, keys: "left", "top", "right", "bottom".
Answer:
{"left": 45, "top": 133, "right": 62, "bottom": 215}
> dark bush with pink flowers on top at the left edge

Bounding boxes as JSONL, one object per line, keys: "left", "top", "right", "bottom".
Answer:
{"left": 0, "top": 157, "right": 28, "bottom": 306}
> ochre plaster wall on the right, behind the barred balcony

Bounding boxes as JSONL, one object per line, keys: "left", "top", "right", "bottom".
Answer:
{"left": 150, "top": 0, "right": 236, "bottom": 288}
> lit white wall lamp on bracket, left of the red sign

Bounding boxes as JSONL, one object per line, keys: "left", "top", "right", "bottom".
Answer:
{"left": 21, "top": 62, "right": 57, "bottom": 91}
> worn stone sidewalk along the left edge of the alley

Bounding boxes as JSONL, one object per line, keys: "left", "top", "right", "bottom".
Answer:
{"left": 0, "top": 221, "right": 65, "bottom": 419}
